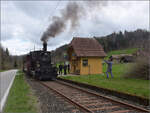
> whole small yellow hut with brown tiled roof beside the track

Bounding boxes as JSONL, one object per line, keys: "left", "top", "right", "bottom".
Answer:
{"left": 67, "top": 37, "right": 106, "bottom": 75}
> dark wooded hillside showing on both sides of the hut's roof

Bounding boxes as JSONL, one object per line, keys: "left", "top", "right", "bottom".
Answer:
{"left": 52, "top": 29, "right": 150, "bottom": 63}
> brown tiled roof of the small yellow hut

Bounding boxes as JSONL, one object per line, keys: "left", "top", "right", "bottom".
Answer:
{"left": 69, "top": 37, "right": 106, "bottom": 57}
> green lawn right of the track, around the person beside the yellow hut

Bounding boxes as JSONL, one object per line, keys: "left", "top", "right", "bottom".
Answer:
{"left": 62, "top": 63, "right": 150, "bottom": 98}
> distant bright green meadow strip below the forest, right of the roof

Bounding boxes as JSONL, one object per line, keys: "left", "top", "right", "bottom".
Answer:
{"left": 107, "top": 48, "right": 138, "bottom": 56}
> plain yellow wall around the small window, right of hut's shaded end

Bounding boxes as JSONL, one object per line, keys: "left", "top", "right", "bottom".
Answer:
{"left": 80, "top": 57, "right": 103, "bottom": 75}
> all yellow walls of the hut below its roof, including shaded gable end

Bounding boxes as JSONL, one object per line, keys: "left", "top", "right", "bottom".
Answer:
{"left": 68, "top": 49, "right": 103, "bottom": 75}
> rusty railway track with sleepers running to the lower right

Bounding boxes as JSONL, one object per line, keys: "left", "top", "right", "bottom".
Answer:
{"left": 40, "top": 80, "right": 149, "bottom": 113}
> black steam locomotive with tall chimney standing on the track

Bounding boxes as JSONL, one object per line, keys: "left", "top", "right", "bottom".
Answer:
{"left": 23, "top": 42, "right": 58, "bottom": 80}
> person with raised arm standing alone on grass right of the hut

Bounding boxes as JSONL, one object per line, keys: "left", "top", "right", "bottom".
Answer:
{"left": 104, "top": 56, "right": 114, "bottom": 78}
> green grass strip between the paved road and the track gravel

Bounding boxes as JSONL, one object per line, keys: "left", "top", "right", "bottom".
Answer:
{"left": 4, "top": 71, "right": 37, "bottom": 113}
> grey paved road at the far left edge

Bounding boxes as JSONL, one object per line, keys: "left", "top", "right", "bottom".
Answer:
{"left": 0, "top": 70, "right": 17, "bottom": 111}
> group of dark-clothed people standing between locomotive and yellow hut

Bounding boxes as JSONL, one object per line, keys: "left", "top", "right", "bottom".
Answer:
{"left": 58, "top": 64, "right": 70, "bottom": 75}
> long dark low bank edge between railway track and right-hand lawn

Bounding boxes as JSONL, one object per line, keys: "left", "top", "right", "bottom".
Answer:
{"left": 58, "top": 78, "right": 150, "bottom": 107}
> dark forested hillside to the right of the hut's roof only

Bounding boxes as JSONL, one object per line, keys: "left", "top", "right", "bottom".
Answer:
{"left": 94, "top": 29, "right": 150, "bottom": 52}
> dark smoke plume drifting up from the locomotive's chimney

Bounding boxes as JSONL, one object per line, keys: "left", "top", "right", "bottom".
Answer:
{"left": 41, "top": 0, "right": 107, "bottom": 42}
